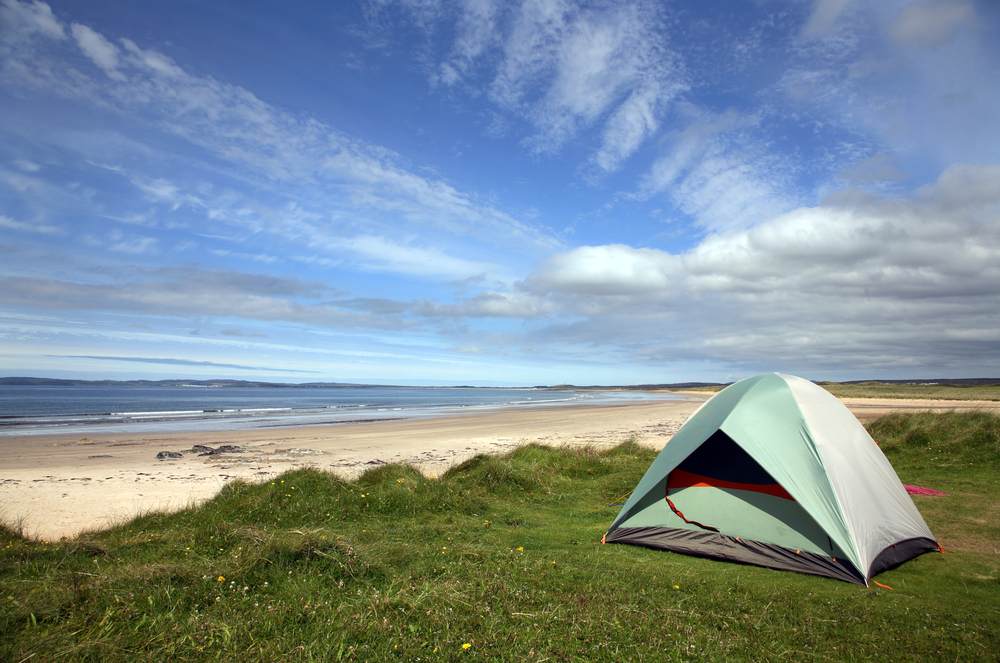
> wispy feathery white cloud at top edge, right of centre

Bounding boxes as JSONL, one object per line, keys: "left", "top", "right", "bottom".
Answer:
{"left": 504, "top": 3, "right": 682, "bottom": 161}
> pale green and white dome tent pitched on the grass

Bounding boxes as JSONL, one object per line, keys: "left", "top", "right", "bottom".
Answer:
{"left": 605, "top": 373, "right": 940, "bottom": 585}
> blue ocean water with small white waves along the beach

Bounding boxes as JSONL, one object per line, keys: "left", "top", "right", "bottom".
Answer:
{"left": 0, "top": 385, "right": 677, "bottom": 436}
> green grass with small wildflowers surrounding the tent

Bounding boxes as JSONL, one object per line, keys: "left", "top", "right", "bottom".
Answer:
{"left": 0, "top": 414, "right": 1000, "bottom": 661}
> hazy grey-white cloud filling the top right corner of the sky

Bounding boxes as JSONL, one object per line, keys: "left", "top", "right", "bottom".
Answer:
{"left": 774, "top": 0, "right": 1000, "bottom": 173}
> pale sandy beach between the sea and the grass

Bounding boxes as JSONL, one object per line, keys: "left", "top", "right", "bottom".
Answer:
{"left": 0, "top": 393, "right": 1000, "bottom": 540}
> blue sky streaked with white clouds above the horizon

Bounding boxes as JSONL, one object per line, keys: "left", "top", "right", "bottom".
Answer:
{"left": 0, "top": 0, "right": 1000, "bottom": 385}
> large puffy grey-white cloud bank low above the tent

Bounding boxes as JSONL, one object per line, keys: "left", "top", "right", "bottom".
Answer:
{"left": 522, "top": 166, "right": 1000, "bottom": 374}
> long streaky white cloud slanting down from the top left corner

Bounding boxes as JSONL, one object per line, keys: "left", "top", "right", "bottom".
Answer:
{"left": 0, "top": 3, "right": 562, "bottom": 278}
